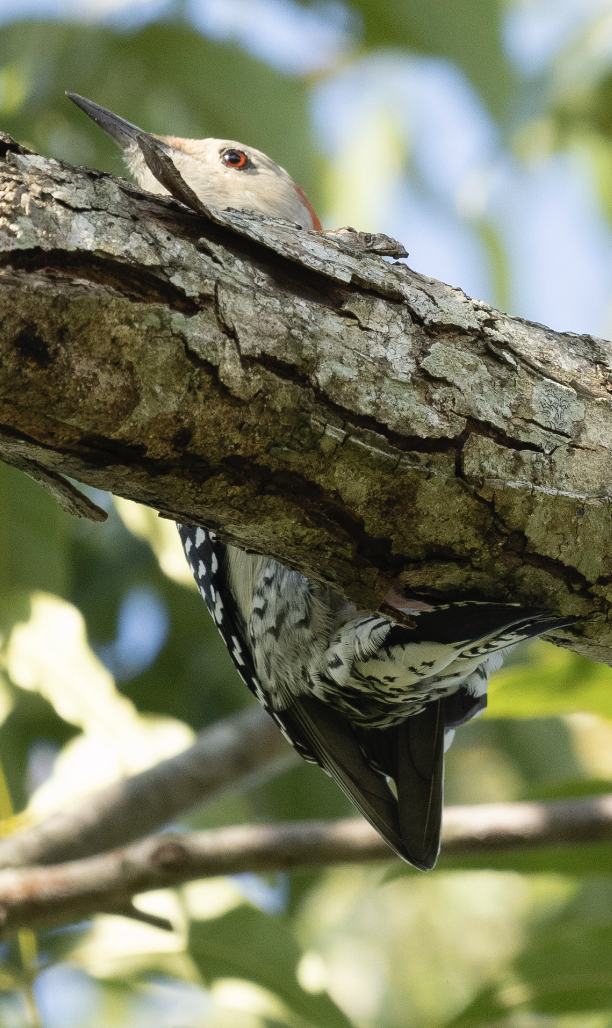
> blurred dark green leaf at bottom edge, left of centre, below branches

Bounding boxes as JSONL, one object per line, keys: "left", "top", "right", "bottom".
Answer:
{"left": 189, "top": 906, "right": 351, "bottom": 1028}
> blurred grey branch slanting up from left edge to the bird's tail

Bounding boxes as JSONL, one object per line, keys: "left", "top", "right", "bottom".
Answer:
{"left": 0, "top": 706, "right": 298, "bottom": 868}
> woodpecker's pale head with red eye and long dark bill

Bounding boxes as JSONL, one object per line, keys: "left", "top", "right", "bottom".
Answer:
{"left": 66, "top": 93, "right": 321, "bottom": 230}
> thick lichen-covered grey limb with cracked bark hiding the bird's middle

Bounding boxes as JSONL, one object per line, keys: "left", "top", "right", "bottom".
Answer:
{"left": 0, "top": 137, "right": 612, "bottom": 662}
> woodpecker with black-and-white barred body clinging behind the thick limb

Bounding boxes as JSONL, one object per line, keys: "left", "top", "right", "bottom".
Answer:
{"left": 67, "top": 93, "right": 576, "bottom": 871}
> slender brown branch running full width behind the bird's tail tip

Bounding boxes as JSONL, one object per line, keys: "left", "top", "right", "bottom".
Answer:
{"left": 0, "top": 795, "right": 612, "bottom": 931}
